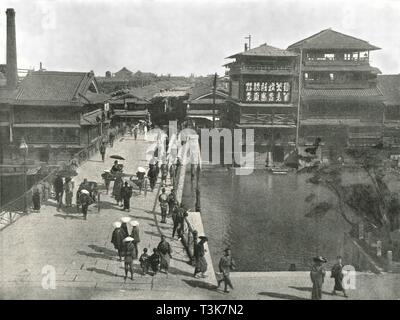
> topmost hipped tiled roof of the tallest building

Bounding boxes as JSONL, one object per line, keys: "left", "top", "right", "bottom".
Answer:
{"left": 288, "top": 29, "right": 380, "bottom": 50}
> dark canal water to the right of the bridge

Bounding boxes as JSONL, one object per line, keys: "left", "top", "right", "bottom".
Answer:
{"left": 184, "top": 167, "right": 349, "bottom": 272}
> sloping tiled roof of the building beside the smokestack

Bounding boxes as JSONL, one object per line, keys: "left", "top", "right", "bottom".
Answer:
{"left": 16, "top": 71, "right": 95, "bottom": 105}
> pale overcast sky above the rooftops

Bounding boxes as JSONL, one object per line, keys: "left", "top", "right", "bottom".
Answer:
{"left": 0, "top": 0, "right": 400, "bottom": 75}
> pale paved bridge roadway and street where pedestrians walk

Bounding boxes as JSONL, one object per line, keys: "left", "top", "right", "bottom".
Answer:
{"left": 0, "top": 137, "right": 400, "bottom": 299}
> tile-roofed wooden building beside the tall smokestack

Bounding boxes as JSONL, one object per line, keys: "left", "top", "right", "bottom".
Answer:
{"left": 2, "top": 71, "right": 107, "bottom": 163}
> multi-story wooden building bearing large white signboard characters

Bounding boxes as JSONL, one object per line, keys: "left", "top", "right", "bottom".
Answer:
{"left": 225, "top": 44, "right": 298, "bottom": 166}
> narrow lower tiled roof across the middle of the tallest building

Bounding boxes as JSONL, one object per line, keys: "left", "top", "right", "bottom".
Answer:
{"left": 302, "top": 88, "right": 382, "bottom": 98}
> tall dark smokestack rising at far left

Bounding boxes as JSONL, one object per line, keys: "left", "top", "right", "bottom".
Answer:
{"left": 6, "top": 8, "right": 18, "bottom": 89}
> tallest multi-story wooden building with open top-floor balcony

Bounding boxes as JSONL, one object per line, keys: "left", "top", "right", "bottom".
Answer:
{"left": 288, "top": 29, "right": 383, "bottom": 156}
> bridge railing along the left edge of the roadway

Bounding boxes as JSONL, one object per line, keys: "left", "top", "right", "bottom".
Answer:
{"left": 0, "top": 137, "right": 107, "bottom": 231}
